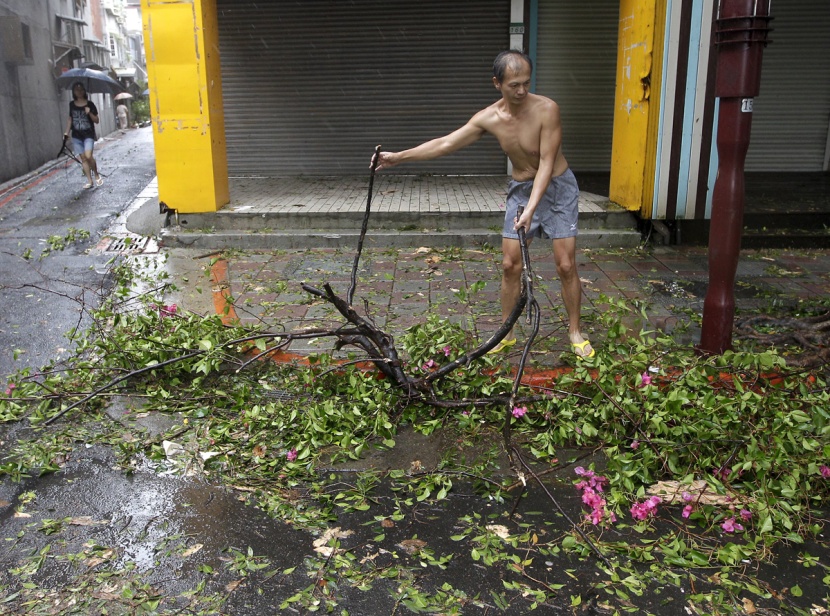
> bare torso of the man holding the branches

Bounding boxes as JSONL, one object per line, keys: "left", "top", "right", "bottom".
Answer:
{"left": 474, "top": 94, "right": 568, "bottom": 182}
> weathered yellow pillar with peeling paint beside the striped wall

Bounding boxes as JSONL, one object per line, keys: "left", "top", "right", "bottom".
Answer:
{"left": 609, "top": 0, "right": 666, "bottom": 218}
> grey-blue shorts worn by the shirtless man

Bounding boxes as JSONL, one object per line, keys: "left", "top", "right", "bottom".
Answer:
{"left": 501, "top": 169, "right": 579, "bottom": 240}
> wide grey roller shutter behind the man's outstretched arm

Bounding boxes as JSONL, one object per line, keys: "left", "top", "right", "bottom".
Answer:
{"left": 217, "top": 0, "right": 510, "bottom": 176}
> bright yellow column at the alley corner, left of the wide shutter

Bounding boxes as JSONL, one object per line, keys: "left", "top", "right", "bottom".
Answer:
{"left": 141, "top": 0, "right": 230, "bottom": 214}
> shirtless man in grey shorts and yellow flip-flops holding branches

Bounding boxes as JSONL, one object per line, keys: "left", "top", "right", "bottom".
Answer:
{"left": 377, "top": 50, "right": 595, "bottom": 357}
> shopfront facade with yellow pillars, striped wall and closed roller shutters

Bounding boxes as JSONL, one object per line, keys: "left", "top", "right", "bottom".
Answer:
{"left": 135, "top": 0, "right": 830, "bottom": 219}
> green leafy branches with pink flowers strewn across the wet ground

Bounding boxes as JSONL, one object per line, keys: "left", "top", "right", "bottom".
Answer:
{"left": 0, "top": 258, "right": 830, "bottom": 614}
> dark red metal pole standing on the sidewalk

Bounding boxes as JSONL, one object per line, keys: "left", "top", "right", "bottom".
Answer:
{"left": 698, "top": 0, "right": 771, "bottom": 354}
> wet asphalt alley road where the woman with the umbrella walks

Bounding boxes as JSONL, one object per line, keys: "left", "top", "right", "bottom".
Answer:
{"left": 0, "top": 127, "right": 155, "bottom": 380}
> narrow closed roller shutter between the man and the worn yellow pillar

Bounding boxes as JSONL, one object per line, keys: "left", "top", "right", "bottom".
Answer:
{"left": 535, "top": 0, "right": 620, "bottom": 172}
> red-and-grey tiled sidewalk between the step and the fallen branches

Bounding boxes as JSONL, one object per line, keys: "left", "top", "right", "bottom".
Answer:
{"left": 185, "top": 242, "right": 830, "bottom": 368}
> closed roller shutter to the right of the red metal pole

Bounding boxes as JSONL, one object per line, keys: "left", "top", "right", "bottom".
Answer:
{"left": 745, "top": 0, "right": 830, "bottom": 171}
